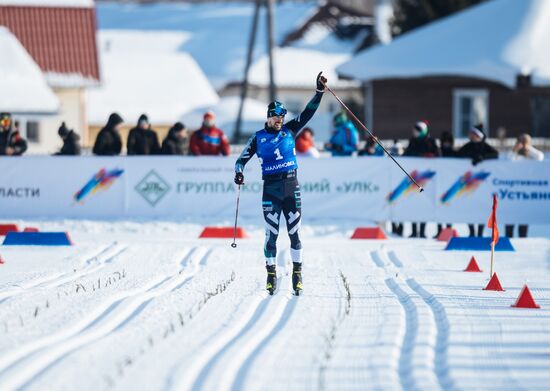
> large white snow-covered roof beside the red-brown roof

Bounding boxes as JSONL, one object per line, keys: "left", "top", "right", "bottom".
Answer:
{"left": 88, "top": 30, "right": 219, "bottom": 125}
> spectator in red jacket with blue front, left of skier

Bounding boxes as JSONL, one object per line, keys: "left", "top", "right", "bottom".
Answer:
{"left": 189, "top": 111, "right": 230, "bottom": 156}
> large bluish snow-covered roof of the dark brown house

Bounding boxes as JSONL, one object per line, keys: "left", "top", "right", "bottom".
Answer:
{"left": 338, "top": 0, "right": 550, "bottom": 87}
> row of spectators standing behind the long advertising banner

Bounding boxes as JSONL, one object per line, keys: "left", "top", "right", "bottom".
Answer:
{"left": 0, "top": 111, "right": 544, "bottom": 238}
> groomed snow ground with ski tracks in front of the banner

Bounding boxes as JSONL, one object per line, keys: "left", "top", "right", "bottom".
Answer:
{"left": 0, "top": 221, "right": 550, "bottom": 391}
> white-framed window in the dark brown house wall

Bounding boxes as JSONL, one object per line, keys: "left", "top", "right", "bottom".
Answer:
{"left": 453, "top": 89, "right": 489, "bottom": 138}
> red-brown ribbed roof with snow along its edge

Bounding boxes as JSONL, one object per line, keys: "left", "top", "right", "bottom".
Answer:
{"left": 0, "top": 0, "right": 100, "bottom": 87}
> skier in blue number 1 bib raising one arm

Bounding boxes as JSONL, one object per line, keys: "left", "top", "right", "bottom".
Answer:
{"left": 235, "top": 72, "right": 327, "bottom": 295}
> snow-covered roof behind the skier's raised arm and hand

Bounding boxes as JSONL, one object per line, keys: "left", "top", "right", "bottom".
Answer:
{"left": 248, "top": 47, "right": 357, "bottom": 89}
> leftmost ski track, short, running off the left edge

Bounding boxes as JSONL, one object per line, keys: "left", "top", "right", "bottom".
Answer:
{"left": 0, "top": 242, "right": 128, "bottom": 304}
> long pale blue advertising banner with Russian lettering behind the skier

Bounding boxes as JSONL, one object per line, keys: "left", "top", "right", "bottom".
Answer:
{"left": 0, "top": 156, "right": 550, "bottom": 224}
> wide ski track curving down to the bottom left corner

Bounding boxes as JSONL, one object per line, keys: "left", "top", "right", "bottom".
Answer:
{"left": 0, "top": 248, "right": 213, "bottom": 390}
